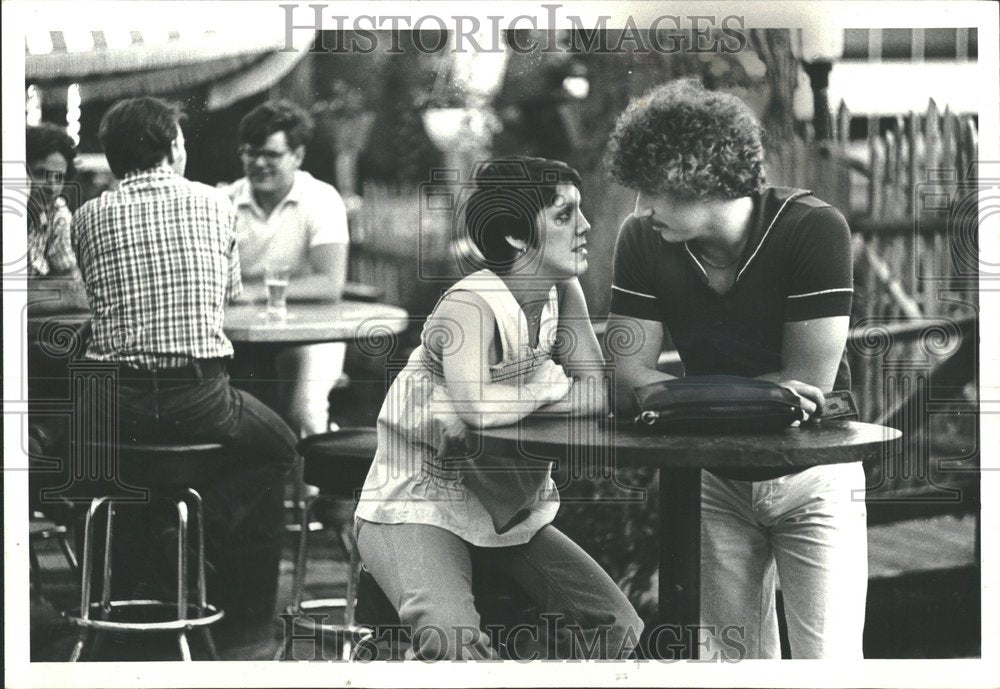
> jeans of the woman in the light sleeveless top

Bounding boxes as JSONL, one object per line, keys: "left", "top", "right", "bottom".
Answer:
{"left": 358, "top": 520, "right": 642, "bottom": 660}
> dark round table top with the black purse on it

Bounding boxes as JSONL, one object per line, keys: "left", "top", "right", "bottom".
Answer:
{"left": 470, "top": 417, "right": 902, "bottom": 469}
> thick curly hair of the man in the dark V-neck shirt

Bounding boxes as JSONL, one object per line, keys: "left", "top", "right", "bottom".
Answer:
{"left": 605, "top": 79, "right": 764, "bottom": 199}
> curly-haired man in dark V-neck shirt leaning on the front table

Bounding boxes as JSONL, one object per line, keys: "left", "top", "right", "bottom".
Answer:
{"left": 607, "top": 81, "right": 868, "bottom": 658}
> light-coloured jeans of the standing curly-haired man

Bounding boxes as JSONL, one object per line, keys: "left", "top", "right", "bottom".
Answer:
{"left": 701, "top": 462, "right": 868, "bottom": 660}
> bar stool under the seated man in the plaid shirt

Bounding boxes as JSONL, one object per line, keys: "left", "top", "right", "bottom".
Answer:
{"left": 63, "top": 443, "right": 231, "bottom": 662}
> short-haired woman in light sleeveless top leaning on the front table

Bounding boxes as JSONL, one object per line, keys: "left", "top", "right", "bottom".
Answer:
{"left": 356, "top": 157, "right": 642, "bottom": 659}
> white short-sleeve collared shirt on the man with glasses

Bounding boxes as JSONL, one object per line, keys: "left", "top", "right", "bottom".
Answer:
{"left": 225, "top": 170, "right": 350, "bottom": 280}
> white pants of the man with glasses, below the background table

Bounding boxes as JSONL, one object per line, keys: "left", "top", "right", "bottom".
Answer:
{"left": 277, "top": 342, "right": 347, "bottom": 437}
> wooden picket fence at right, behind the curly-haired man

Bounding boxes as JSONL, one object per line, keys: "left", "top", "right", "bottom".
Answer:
{"left": 769, "top": 100, "right": 978, "bottom": 421}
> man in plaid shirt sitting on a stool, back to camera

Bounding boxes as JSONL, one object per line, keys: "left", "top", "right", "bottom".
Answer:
{"left": 72, "top": 97, "right": 296, "bottom": 584}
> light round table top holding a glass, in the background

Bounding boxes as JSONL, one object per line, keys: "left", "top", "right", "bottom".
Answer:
{"left": 223, "top": 301, "right": 407, "bottom": 344}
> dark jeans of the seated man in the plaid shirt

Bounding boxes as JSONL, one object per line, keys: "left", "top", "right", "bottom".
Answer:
{"left": 110, "top": 372, "right": 296, "bottom": 539}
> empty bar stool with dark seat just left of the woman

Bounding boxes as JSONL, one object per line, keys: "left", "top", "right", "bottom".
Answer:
{"left": 275, "top": 428, "right": 377, "bottom": 660}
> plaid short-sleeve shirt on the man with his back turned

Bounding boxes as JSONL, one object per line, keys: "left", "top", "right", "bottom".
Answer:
{"left": 72, "top": 167, "right": 243, "bottom": 369}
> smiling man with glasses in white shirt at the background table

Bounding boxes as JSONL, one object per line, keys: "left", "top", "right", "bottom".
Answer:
{"left": 226, "top": 101, "right": 350, "bottom": 436}
